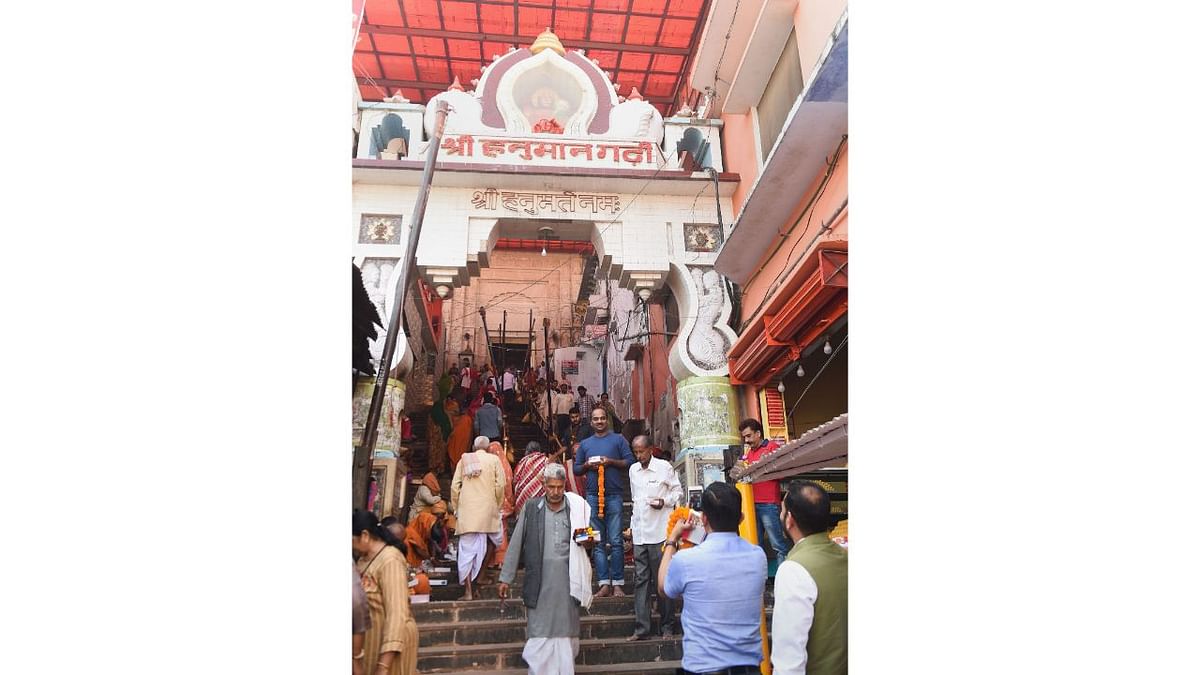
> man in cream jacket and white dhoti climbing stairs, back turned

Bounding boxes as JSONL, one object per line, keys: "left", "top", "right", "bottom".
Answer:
{"left": 450, "top": 436, "right": 505, "bottom": 601}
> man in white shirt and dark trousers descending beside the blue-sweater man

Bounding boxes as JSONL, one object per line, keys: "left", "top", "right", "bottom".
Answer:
{"left": 628, "top": 436, "right": 683, "bottom": 641}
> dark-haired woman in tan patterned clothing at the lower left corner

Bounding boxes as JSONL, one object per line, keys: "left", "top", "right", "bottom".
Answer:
{"left": 350, "top": 510, "right": 418, "bottom": 675}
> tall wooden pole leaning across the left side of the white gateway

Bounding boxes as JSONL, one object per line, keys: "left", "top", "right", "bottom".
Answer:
{"left": 352, "top": 101, "right": 449, "bottom": 509}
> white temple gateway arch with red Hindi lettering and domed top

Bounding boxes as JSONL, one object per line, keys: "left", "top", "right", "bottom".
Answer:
{"left": 349, "top": 31, "right": 740, "bottom": 488}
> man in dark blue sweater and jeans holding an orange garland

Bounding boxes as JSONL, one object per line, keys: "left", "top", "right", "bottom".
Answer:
{"left": 575, "top": 407, "right": 634, "bottom": 590}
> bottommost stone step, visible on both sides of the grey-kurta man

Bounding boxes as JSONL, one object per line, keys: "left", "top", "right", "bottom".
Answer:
{"left": 416, "top": 637, "right": 683, "bottom": 673}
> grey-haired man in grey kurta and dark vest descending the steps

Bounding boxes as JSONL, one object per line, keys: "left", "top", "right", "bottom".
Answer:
{"left": 498, "top": 464, "right": 580, "bottom": 675}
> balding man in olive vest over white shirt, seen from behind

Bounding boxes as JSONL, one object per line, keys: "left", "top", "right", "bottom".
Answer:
{"left": 770, "top": 480, "right": 847, "bottom": 675}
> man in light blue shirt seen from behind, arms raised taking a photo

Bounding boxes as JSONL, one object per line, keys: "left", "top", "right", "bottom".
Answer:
{"left": 659, "top": 483, "right": 767, "bottom": 675}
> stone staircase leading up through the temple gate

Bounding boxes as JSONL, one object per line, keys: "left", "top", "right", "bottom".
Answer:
{"left": 413, "top": 503, "right": 773, "bottom": 675}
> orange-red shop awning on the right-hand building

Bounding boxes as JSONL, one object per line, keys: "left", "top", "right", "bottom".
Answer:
{"left": 730, "top": 240, "right": 850, "bottom": 386}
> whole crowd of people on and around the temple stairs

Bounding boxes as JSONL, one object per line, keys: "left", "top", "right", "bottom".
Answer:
{"left": 354, "top": 355, "right": 847, "bottom": 675}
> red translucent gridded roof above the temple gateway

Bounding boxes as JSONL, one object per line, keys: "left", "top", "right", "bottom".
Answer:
{"left": 354, "top": 0, "right": 710, "bottom": 117}
